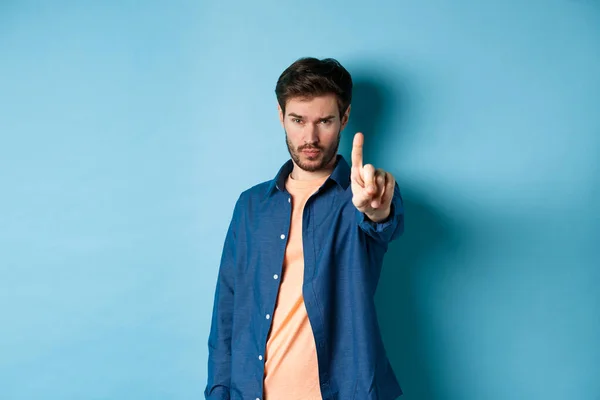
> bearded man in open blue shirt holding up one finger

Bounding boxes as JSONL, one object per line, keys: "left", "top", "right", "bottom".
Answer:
{"left": 204, "top": 58, "right": 404, "bottom": 400}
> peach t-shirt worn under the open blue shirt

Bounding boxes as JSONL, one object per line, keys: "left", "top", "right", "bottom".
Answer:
{"left": 264, "top": 175, "right": 328, "bottom": 400}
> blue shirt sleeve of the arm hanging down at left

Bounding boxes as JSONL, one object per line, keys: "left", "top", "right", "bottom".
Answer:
{"left": 204, "top": 196, "right": 241, "bottom": 400}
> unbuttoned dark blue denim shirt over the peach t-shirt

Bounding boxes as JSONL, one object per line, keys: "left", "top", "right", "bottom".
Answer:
{"left": 204, "top": 155, "right": 404, "bottom": 400}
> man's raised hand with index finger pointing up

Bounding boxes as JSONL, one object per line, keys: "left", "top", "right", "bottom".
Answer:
{"left": 350, "top": 132, "right": 396, "bottom": 222}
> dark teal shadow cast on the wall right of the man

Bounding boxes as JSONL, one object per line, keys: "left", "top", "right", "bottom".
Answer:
{"left": 340, "top": 74, "right": 458, "bottom": 400}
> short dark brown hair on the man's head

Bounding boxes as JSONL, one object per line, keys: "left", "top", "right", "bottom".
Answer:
{"left": 275, "top": 57, "right": 352, "bottom": 118}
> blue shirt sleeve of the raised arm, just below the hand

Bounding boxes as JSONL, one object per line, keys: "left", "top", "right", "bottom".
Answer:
{"left": 356, "top": 183, "right": 404, "bottom": 245}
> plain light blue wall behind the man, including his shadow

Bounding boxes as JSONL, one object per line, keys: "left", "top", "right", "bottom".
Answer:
{"left": 0, "top": 0, "right": 600, "bottom": 400}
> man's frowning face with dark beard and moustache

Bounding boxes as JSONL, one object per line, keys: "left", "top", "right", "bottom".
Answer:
{"left": 279, "top": 94, "right": 350, "bottom": 172}
